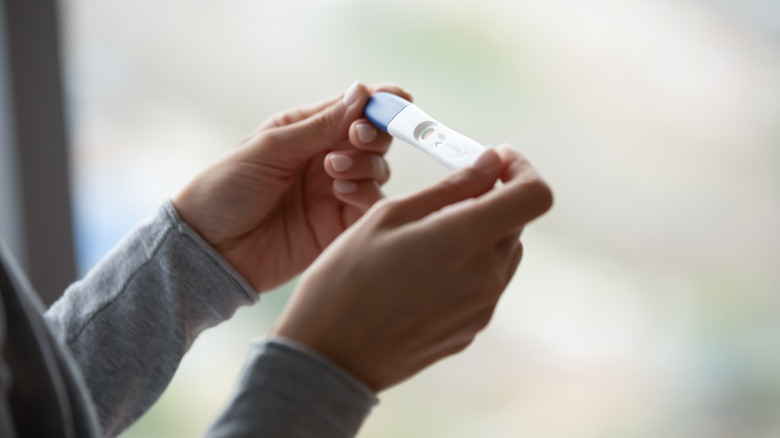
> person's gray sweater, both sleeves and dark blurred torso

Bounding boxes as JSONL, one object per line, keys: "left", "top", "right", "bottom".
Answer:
{"left": 0, "top": 203, "right": 377, "bottom": 438}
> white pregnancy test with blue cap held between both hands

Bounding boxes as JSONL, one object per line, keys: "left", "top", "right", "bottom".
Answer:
{"left": 364, "top": 91, "right": 487, "bottom": 170}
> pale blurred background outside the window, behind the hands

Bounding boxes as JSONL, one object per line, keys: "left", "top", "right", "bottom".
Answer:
{"left": 4, "top": 0, "right": 780, "bottom": 438}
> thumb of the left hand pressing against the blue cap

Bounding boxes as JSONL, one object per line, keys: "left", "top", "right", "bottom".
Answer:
{"left": 269, "top": 81, "right": 370, "bottom": 159}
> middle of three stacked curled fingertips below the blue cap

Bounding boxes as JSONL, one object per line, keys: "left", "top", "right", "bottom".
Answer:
{"left": 325, "top": 149, "right": 390, "bottom": 185}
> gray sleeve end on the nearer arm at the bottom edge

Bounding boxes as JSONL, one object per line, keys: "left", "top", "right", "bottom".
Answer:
{"left": 206, "top": 339, "right": 377, "bottom": 438}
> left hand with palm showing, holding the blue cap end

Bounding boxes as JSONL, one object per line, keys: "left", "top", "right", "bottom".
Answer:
{"left": 173, "top": 83, "right": 411, "bottom": 292}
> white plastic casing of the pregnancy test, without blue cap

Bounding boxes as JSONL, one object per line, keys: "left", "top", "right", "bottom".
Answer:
{"left": 387, "top": 104, "right": 487, "bottom": 170}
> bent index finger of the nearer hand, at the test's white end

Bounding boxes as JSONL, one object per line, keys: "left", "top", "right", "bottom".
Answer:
{"left": 439, "top": 146, "right": 553, "bottom": 246}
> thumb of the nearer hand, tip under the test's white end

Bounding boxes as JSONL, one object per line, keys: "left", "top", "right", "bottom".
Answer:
{"left": 386, "top": 149, "right": 502, "bottom": 223}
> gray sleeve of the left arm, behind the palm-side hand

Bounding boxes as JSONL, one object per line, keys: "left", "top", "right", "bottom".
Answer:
{"left": 46, "top": 203, "right": 257, "bottom": 435}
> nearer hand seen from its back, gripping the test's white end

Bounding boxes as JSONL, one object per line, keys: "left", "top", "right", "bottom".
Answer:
{"left": 273, "top": 146, "right": 552, "bottom": 391}
